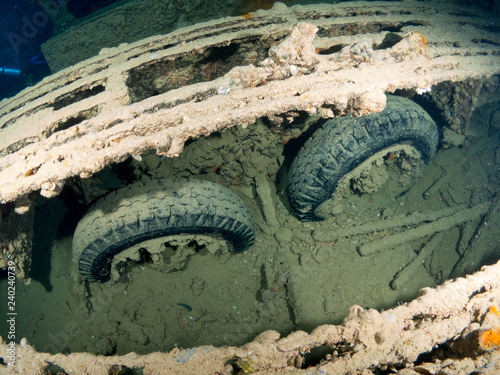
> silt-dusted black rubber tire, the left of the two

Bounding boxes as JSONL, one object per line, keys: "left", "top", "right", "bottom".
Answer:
{"left": 73, "top": 179, "right": 255, "bottom": 282}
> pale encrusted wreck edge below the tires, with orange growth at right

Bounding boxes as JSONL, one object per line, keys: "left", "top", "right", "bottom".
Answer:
{"left": 0, "top": 263, "right": 500, "bottom": 375}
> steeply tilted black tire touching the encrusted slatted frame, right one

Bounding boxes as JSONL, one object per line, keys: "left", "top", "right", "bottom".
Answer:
{"left": 287, "top": 96, "right": 439, "bottom": 221}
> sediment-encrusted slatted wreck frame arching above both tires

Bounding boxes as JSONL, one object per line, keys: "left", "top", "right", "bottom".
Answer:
{"left": 0, "top": 2, "right": 500, "bottom": 277}
